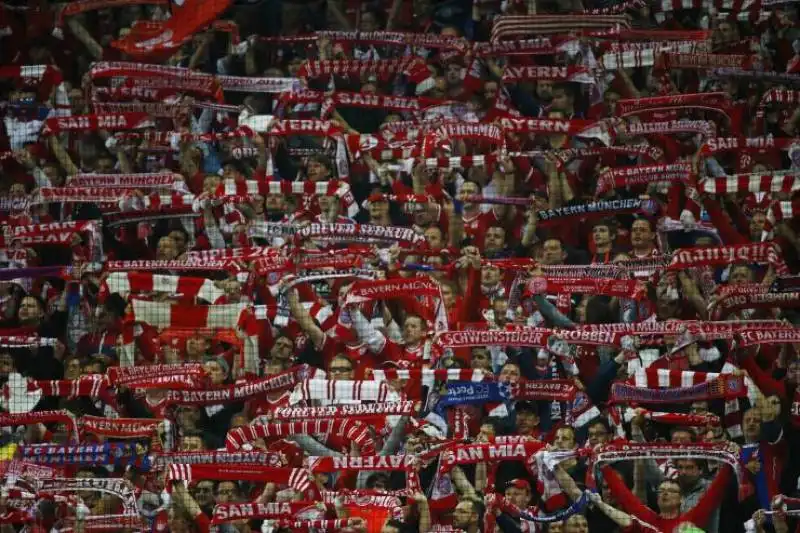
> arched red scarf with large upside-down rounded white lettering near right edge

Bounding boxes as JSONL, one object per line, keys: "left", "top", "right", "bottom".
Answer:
{"left": 668, "top": 242, "right": 788, "bottom": 274}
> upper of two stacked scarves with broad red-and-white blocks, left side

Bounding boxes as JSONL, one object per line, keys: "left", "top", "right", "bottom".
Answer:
{"left": 100, "top": 272, "right": 225, "bottom": 304}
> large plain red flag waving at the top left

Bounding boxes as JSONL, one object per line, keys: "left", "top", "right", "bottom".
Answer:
{"left": 111, "top": 0, "right": 233, "bottom": 59}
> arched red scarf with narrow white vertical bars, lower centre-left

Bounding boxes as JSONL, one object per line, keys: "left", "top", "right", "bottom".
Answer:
{"left": 225, "top": 419, "right": 375, "bottom": 455}
